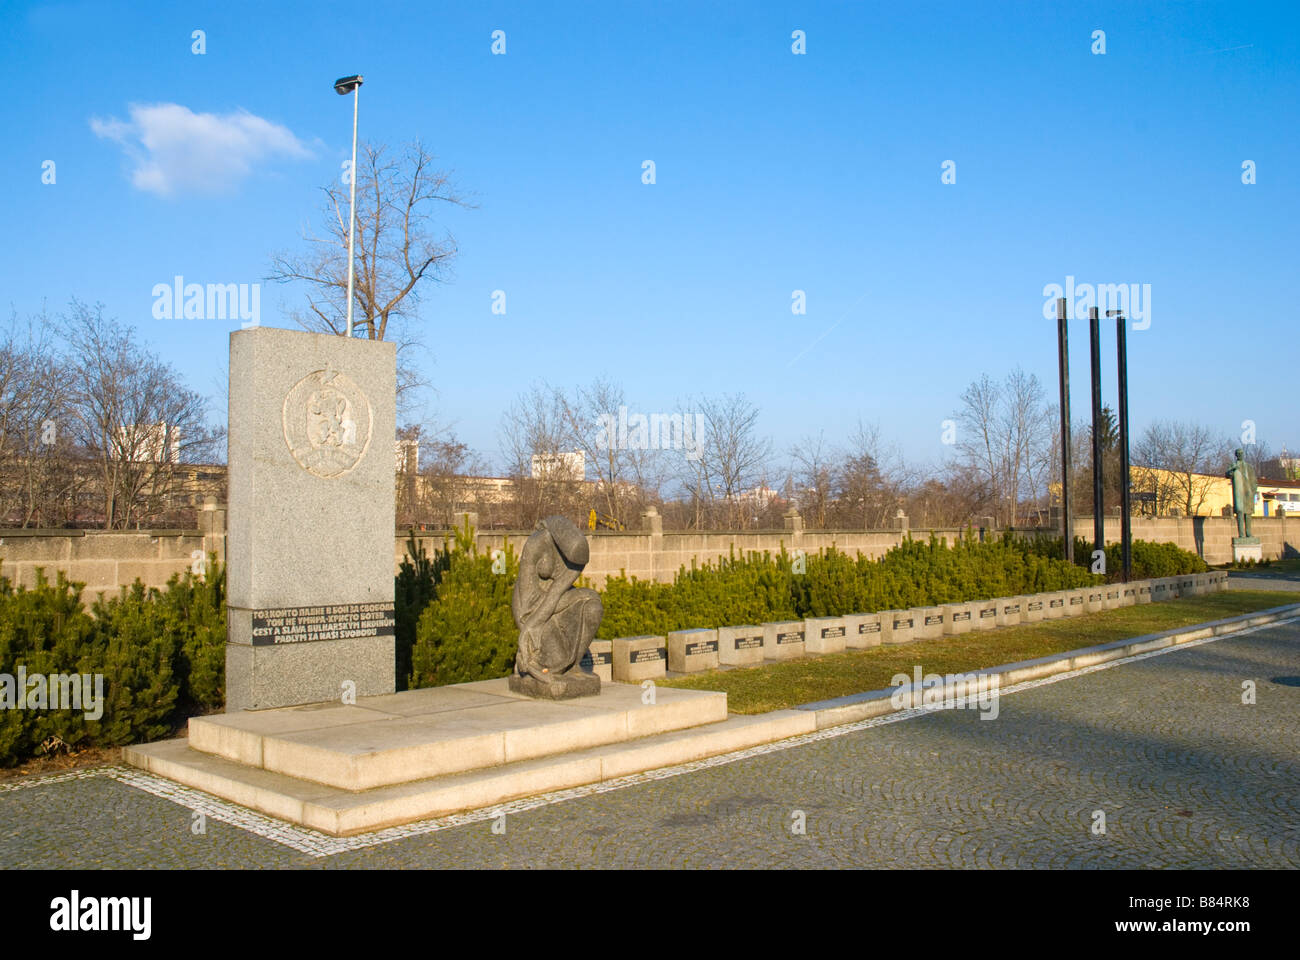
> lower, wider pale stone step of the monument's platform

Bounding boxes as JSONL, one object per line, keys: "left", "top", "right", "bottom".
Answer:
{"left": 124, "top": 707, "right": 816, "bottom": 836}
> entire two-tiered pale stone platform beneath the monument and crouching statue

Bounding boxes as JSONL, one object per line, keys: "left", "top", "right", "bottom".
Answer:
{"left": 124, "top": 678, "right": 815, "bottom": 835}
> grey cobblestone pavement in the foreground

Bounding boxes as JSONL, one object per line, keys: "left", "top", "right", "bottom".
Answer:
{"left": 0, "top": 622, "right": 1300, "bottom": 868}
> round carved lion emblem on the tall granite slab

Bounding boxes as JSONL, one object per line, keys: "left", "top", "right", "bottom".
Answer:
{"left": 283, "top": 367, "right": 373, "bottom": 477}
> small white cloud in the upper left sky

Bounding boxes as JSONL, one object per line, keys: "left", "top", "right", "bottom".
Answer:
{"left": 90, "top": 103, "right": 311, "bottom": 196}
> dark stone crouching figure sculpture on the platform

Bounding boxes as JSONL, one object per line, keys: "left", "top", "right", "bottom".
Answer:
{"left": 510, "top": 516, "right": 602, "bottom": 700}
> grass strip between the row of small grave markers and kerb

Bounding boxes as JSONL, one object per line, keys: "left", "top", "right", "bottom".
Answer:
{"left": 659, "top": 589, "right": 1300, "bottom": 713}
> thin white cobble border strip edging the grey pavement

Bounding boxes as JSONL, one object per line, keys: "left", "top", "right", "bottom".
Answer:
{"left": 0, "top": 608, "right": 1300, "bottom": 857}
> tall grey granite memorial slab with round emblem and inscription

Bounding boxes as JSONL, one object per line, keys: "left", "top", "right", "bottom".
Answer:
{"left": 226, "top": 327, "right": 397, "bottom": 713}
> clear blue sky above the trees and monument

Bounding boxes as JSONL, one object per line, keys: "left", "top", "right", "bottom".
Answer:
{"left": 0, "top": 0, "right": 1300, "bottom": 463}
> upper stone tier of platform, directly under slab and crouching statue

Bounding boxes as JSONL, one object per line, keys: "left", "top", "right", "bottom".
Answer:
{"left": 189, "top": 678, "right": 727, "bottom": 791}
